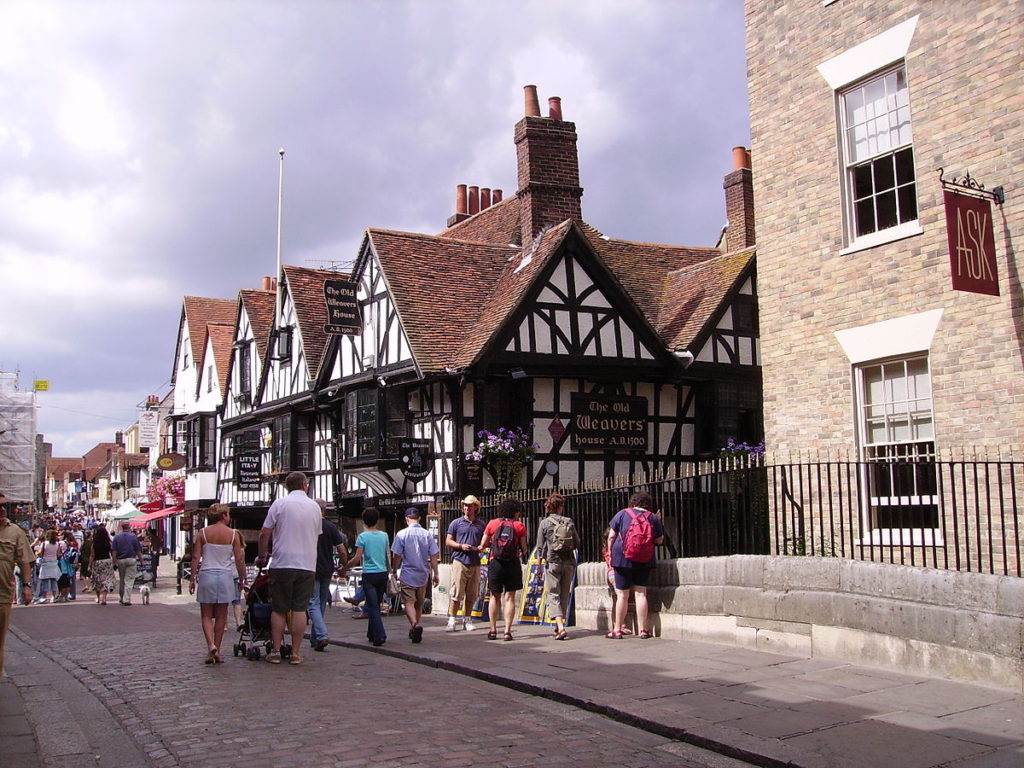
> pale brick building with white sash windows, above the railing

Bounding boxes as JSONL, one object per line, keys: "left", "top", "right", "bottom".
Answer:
{"left": 746, "top": 0, "right": 1024, "bottom": 573}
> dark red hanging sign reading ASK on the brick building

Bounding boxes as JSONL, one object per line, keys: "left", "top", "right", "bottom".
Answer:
{"left": 942, "top": 189, "right": 999, "bottom": 296}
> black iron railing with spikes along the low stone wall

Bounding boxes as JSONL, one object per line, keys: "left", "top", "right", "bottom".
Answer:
{"left": 442, "top": 459, "right": 1024, "bottom": 577}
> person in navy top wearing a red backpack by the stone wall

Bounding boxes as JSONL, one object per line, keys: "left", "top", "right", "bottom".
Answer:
{"left": 605, "top": 490, "right": 665, "bottom": 640}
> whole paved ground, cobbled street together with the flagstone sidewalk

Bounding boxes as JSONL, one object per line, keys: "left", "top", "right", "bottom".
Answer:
{"left": 0, "top": 565, "right": 1024, "bottom": 768}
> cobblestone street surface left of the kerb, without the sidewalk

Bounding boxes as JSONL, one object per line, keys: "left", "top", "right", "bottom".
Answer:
{"left": 2, "top": 594, "right": 738, "bottom": 768}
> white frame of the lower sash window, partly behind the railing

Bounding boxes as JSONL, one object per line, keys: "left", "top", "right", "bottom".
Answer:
{"left": 854, "top": 352, "right": 942, "bottom": 546}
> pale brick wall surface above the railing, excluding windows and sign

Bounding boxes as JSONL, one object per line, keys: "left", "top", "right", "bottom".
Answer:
{"left": 746, "top": 0, "right": 1024, "bottom": 451}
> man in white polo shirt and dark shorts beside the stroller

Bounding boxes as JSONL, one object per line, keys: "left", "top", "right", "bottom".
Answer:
{"left": 256, "top": 472, "right": 321, "bottom": 665}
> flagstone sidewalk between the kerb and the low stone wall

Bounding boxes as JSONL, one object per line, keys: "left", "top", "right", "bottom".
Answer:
{"left": 328, "top": 609, "right": 1024, "bottom": 768}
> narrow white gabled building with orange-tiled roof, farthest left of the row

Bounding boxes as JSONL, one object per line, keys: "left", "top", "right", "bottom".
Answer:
{"left": 170, "top": 296, "right": 234, "bottom": 518}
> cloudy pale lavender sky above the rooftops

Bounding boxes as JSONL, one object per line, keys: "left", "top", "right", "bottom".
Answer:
{"left": 0, "top": 0, "right": 750, "bottom": 457}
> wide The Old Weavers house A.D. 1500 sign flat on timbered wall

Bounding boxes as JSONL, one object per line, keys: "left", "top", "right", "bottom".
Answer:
{"left": 569, "top": 392, "right": 647, "bottom": 451}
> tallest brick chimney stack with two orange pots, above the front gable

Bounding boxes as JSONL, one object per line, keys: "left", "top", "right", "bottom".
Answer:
{"left": 515, "top": 85, "right": 583, "bottom": 250}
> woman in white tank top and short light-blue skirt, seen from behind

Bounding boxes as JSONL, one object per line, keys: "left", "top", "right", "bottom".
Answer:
{"left": 188, "top": 504, "right": 246, "bottom": 664}
